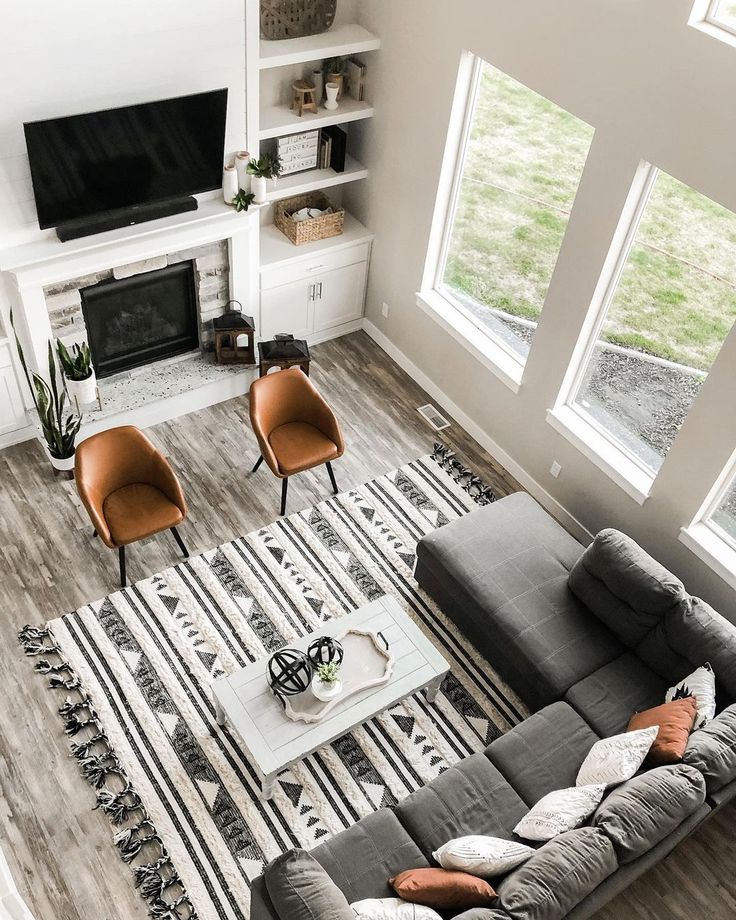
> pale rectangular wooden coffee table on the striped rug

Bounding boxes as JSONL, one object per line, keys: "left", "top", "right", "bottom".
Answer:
{"left": 212, "top": 595, "right": 450, "bottom": 799}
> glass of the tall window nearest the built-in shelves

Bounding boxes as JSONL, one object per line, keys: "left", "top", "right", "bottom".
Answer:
{"left": 437, "top": 55, "right": 593, "bottom": 363}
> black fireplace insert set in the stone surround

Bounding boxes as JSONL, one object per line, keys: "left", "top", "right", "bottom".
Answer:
{"left": 80, "top": 262, "right": 199, "bottom": 377}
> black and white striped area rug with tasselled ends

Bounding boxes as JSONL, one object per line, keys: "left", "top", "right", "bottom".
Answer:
{"left": 21, "top": 445, "right": 524, "bottom": 920}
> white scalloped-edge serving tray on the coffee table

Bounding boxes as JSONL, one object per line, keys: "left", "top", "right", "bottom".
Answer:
{"left": 284, "top": 628, "right": 394, "bottom": 723}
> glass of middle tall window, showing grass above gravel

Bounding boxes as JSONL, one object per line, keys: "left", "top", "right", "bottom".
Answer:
{"left": 570, "top": 168, "right": 736, "bottom": 474}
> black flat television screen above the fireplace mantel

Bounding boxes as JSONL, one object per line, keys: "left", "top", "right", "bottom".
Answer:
{"left": 23, "top": 89, "right": 227, "bottom": 229}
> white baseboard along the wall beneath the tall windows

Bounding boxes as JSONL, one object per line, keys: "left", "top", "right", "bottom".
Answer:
{"left": 363, "top": 319, "right": 593, "bottom": 545}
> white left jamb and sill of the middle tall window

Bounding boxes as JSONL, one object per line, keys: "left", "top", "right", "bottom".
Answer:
{"left": 547, "top": 162, "right": 659, "bottom": 505}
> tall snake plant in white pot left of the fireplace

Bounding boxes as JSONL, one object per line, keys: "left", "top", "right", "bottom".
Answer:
{"left": 10, "top": 313, "right": 82, "bottom": 472}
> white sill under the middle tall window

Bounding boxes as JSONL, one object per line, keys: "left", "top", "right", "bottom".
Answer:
{"left": 547, "top": 406, "right": 654, "bottom": 505}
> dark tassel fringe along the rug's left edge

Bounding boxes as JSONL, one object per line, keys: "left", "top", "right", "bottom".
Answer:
{"left": 18, "top": 625, "right": 198, "bottom": 920}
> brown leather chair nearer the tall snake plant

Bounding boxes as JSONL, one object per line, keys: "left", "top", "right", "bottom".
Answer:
{"left": 74, "top": 425, "right": 189, "bottom": 588}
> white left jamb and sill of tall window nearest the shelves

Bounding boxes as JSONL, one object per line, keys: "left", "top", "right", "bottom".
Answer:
{"left": 417, "top": 51, "right": 525, "bottom": 393}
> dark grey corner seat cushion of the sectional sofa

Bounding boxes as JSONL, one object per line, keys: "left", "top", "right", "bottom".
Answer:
{"left": 565, "top": 652, "right": 669, "bottom": 738}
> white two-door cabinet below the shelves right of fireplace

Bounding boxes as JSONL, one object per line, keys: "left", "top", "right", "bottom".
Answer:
{"left": 258, "top": 243, "right": 370, "bottom": 341}
